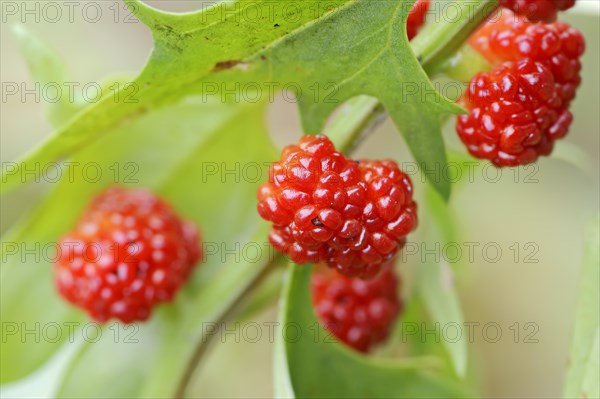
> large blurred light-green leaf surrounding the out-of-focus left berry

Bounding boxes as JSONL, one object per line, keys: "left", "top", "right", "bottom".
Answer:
{"left": 0, "top": 98, "right": 275, "bottom": 397}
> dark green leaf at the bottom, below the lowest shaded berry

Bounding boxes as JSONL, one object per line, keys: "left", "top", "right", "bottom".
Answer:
{"left": 275, "top": 265, "right": 470, "bottom": 398}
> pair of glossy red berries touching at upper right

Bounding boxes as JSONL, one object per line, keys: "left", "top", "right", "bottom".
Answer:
{"left": 456, "top": 10, "right": 585, "bottom": 166}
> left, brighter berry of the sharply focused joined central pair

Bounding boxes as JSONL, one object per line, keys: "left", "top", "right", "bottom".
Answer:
{"left": 258, "top": 136, "right": 361, "bottom": 263}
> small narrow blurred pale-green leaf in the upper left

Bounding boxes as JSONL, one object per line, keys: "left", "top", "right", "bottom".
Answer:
{"left": 13, "top": 25, "right": 86, "bottom": 127}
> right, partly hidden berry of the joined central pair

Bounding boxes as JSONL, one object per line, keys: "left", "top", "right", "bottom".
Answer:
{"left": 327, "top": 160, "right": 417, "bottom": 279}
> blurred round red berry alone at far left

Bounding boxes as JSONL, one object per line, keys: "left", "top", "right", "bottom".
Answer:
{"left": 55, "top": 187, "right": 201, "bottom": 323}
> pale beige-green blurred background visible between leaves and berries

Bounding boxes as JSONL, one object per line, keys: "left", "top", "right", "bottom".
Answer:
{"left": 0, "top": 0, "right": 600, "bottom": 398}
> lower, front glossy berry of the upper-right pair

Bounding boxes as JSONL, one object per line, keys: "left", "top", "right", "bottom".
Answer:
{"left": 456, "top": 59, "right": 572, "bottom": 166}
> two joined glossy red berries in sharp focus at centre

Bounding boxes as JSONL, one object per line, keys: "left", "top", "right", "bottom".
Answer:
{"left": 258, "top": 135, "right": 417, "bottom": 279}
